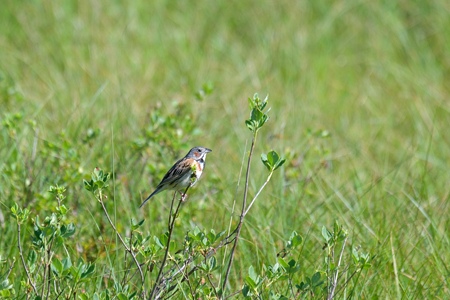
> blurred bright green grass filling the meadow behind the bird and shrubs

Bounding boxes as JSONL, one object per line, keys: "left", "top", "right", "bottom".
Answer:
{"left": 0, "top": 0, "right": 450, "bottom": 299}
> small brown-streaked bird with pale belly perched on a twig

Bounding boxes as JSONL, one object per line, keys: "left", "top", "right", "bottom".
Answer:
{"left": 139, "top": 147, "right": 212, "bottom": 208}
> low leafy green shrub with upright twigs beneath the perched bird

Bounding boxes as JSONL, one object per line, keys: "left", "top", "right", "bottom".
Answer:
{"left": 0, "top": 94, "right": 372, "bottom": 299}
